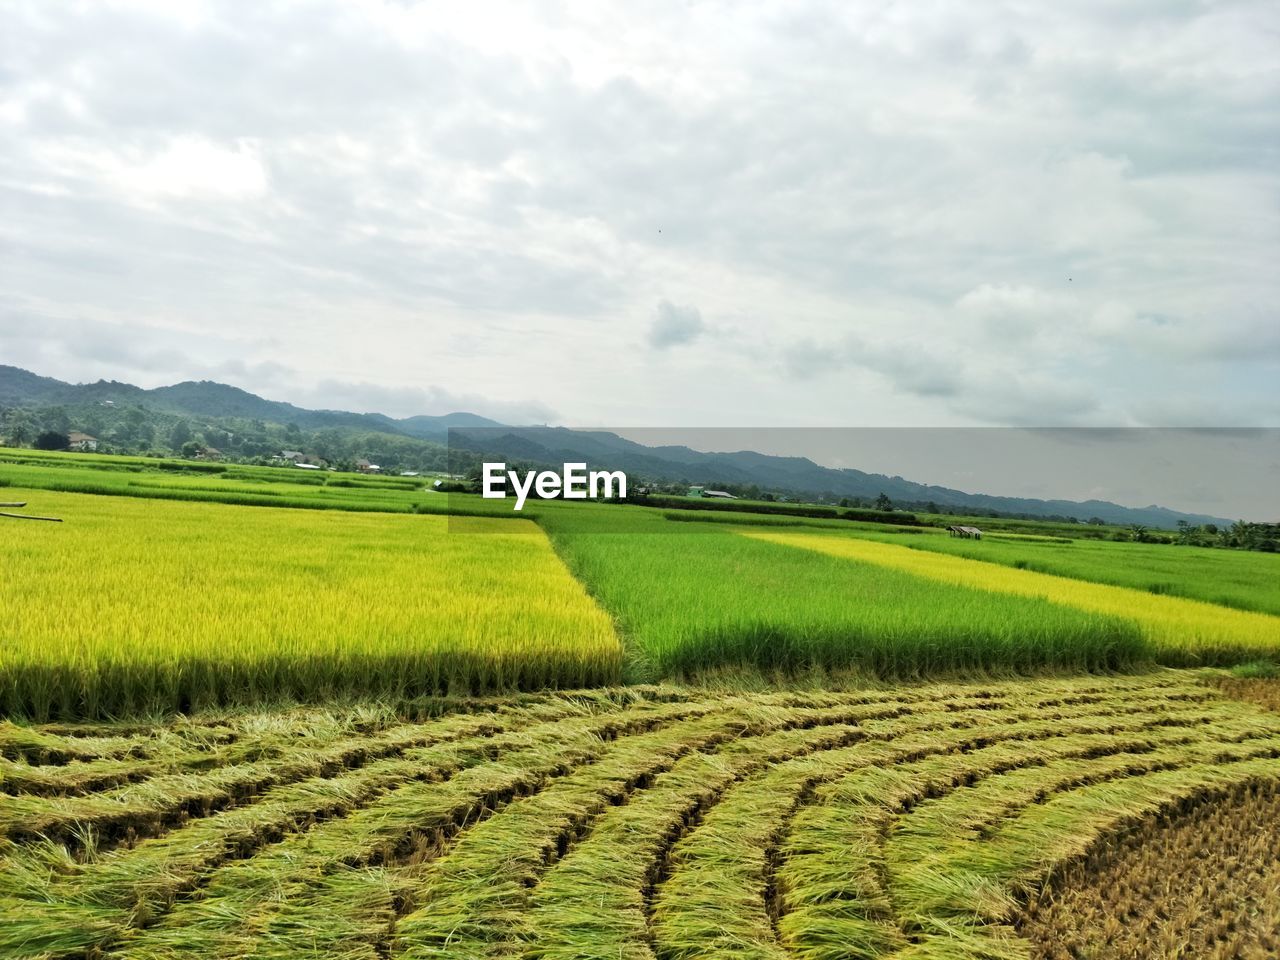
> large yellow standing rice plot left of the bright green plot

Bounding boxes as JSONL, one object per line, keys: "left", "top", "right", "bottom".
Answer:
{"left": 0, "top": 490, "right": 621, "bottom": 719}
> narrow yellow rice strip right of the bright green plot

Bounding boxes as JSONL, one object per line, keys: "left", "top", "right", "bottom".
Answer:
{"left": 742, "top": 530, "right": 1280, "bottom": 666}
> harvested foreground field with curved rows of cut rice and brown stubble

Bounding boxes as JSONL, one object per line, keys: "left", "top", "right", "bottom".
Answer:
{"left": 0, "top": 671, "right": 1280, "bottom": 960}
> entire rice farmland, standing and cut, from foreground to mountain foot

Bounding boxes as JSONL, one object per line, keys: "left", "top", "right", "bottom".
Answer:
{"left": 0, "top": 461, "right": 1280, "bottom": 960}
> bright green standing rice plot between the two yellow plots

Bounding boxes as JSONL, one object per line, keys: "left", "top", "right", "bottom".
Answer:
{"left": 541, "top": 508, "right": 1148, "bottom": 680}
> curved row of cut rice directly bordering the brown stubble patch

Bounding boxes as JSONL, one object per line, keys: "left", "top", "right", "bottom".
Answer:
{"left": 778, "top": 701, "right": 1280, "bottom": 960}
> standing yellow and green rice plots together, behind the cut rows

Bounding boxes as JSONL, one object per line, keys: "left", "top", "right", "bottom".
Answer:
{"left": 10, "top": 481, "right": 1280, "bottom": 719}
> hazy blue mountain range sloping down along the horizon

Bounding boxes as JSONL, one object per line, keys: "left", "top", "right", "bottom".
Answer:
{"left": 0, "top": 365, "right": 1230, "bottom": 529}
